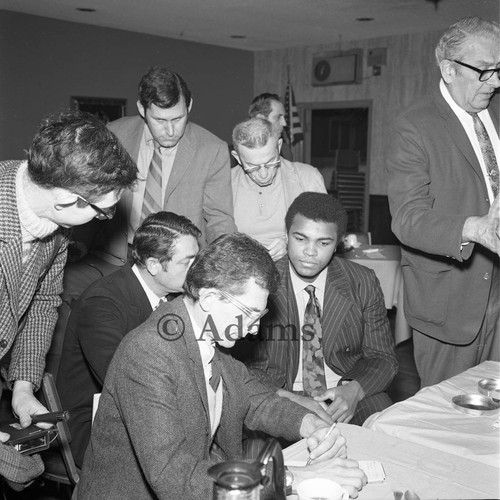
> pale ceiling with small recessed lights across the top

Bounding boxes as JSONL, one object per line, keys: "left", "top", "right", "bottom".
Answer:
{"left": 0, "top": 0, "right": 500, "bottom": 51}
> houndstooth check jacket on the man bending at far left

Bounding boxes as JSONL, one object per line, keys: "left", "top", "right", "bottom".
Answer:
{"left": 0, "top": 161, "right": 68, "bottom": 389}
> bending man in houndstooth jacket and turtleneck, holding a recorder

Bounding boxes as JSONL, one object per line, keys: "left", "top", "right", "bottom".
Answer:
{"left": 0, "top": 112, "right": 137, "bottom": 487}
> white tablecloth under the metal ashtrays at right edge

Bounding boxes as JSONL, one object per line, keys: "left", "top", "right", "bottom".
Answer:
{"left": 364, "top": 361, "right": 500, "bottom": 468}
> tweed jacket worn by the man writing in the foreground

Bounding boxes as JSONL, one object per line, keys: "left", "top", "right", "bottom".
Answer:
{"left": 77, "top": 298, "right": 308, "bottom": 500}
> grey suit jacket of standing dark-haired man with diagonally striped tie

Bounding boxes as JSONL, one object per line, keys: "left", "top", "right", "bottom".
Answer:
{"left": 75, "top": 116, "right": 236, "bottom": 266}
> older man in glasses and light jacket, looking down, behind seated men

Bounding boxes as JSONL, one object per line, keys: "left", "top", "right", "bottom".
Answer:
{"left": 231, "top": 118, "right": 326, "bottom": 261}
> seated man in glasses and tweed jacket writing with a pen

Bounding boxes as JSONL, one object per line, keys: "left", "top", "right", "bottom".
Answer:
{"left": 75, "top": 233, "right": 366, "bottom": 500}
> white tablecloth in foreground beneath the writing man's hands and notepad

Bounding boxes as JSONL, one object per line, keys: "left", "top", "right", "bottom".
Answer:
{"left": 284, "top": 424, "right": 500, "bottom": 500}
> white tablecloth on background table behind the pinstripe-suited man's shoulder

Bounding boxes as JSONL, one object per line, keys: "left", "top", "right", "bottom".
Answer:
{"left": 343, "top": 245, "right": 411, "bottom": 344}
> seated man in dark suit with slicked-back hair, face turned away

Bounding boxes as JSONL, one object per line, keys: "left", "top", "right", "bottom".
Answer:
{"left": 57, "top": 212, "right": 201, "bottom": 467}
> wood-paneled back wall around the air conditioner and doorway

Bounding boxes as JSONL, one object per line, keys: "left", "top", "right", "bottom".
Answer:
{"left": 254, "top": 32, "right": 442, "bottom": 194}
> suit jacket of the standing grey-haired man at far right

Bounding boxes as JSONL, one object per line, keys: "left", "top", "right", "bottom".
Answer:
{"left": 387, "top": 89, "right": 500, "bottom": 345}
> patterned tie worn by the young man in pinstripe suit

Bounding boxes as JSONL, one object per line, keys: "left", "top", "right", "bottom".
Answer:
{"left": 302, "top": 285, "right": 326, "bottom": 397}
